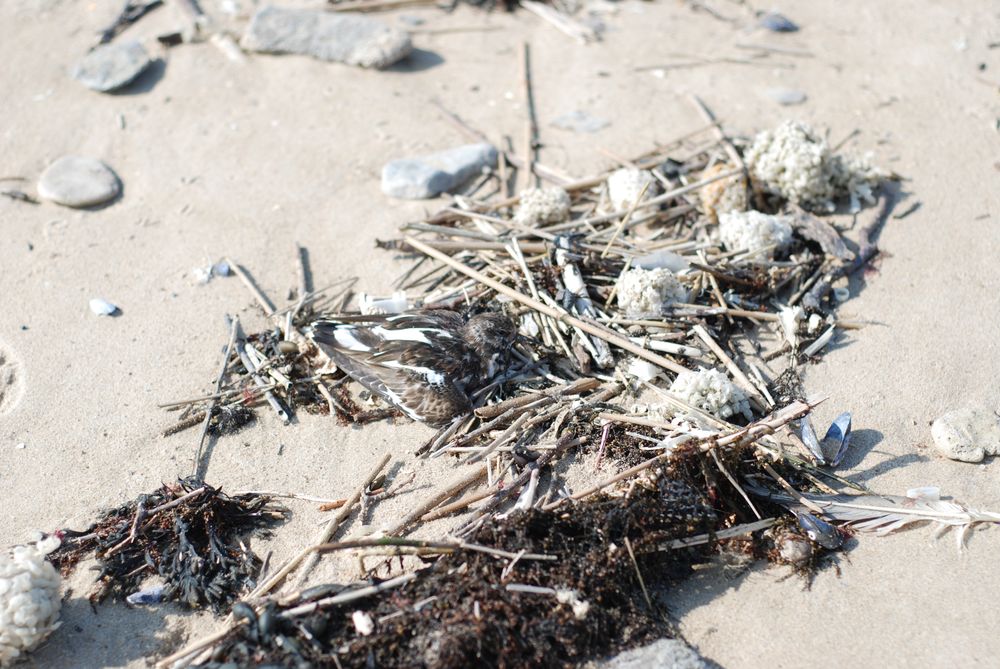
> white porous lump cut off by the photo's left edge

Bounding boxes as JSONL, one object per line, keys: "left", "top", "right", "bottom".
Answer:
{"left": 0, "top": 537, "right": 61, "bottom": 667}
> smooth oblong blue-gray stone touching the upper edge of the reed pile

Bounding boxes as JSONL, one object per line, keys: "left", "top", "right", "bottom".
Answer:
{"left": 382, "top": 144, "right": 497, "bottom": 200}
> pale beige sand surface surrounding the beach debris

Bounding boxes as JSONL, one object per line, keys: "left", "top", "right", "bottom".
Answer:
{"left": 0, "top": 0, "right": 1000, "bottom": 668}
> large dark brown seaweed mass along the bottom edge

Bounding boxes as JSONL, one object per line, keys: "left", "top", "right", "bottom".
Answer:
{"left": 203, "top": 478, "right": 718, "bottom": 669}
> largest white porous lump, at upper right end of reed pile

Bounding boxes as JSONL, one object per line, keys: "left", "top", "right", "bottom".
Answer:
{"left": 744, "top": 121, "right": 886, "bottom": 212}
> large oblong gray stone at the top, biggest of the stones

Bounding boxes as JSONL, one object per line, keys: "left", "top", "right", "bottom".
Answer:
{"left": 240, "top": 6, "right": 413, "bottom": 68}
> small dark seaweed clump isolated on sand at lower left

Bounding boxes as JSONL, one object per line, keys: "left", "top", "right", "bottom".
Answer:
{"left": 52, "top": 480, "right": 288, "bottom": 613}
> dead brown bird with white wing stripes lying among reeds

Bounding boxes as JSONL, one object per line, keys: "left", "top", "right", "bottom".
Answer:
{"left": 310, "top": 310, "right": 517, "bottom": 427}
